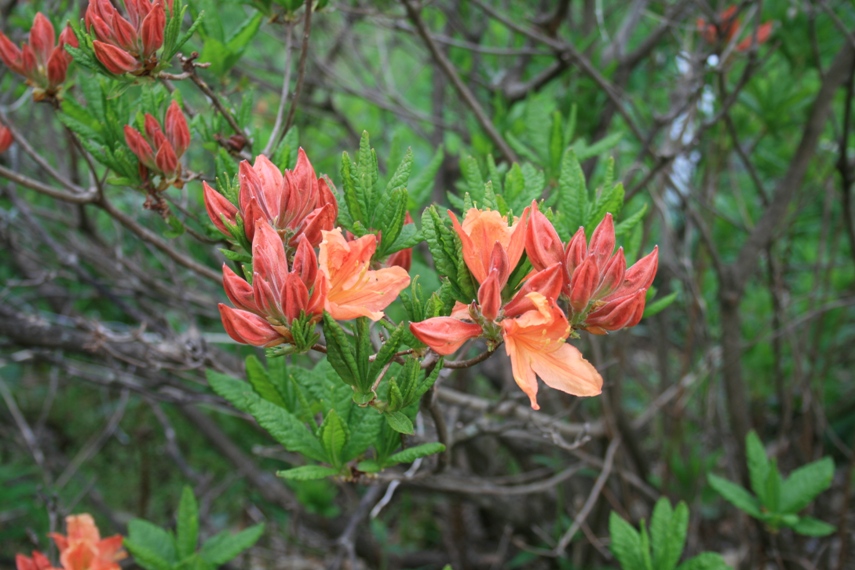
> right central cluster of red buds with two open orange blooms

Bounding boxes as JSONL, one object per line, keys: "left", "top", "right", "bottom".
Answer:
{"left": 410, "top": 203, "right": 657, "bottom": 410}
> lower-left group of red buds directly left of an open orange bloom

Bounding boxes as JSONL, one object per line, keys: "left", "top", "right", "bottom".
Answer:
{"left": 219, "top": 220, "right": 327, "bottom": 347}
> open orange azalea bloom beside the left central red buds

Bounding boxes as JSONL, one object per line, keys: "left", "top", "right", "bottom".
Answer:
{"left": 319, "top": 228, "right": 410, "bottom": 321}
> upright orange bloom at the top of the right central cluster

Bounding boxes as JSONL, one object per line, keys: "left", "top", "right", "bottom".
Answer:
{"left": 448, "top": 208, "right": 529, "bottom": 287}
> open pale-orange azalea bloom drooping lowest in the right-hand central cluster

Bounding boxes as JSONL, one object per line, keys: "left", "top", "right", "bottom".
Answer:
{"left": 501, "top": 292, "right": 603, "bottom": 410}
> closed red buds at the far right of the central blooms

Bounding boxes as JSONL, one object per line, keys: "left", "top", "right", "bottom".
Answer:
{"left": 526, "top": 203, "right": 659, "bottom": 334}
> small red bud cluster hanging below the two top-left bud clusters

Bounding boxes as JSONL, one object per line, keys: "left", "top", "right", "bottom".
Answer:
{"left": 125, "top": 101, "right": 190, "bottom": 186}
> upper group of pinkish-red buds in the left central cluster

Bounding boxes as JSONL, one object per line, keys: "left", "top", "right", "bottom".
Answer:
{"left": 204, "top": 148, "right": 338, "bottom": 253}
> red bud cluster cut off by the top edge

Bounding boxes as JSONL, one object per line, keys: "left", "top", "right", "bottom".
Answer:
{"left": 84, "top": 0, "right": 172, "bottom": 75}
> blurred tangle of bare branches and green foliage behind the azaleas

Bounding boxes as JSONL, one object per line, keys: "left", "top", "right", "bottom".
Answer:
{"left": 0, "top": 0, "right": 855, "bottom": 570}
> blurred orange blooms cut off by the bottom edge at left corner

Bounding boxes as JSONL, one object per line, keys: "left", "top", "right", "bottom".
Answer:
{"left": 15, "top": 514, "right": 127, "bottom": 570}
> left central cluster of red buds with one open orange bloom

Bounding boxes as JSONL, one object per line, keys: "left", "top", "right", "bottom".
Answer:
{"left": 204, "top": 149, "right": 410, "bottom": 348}
